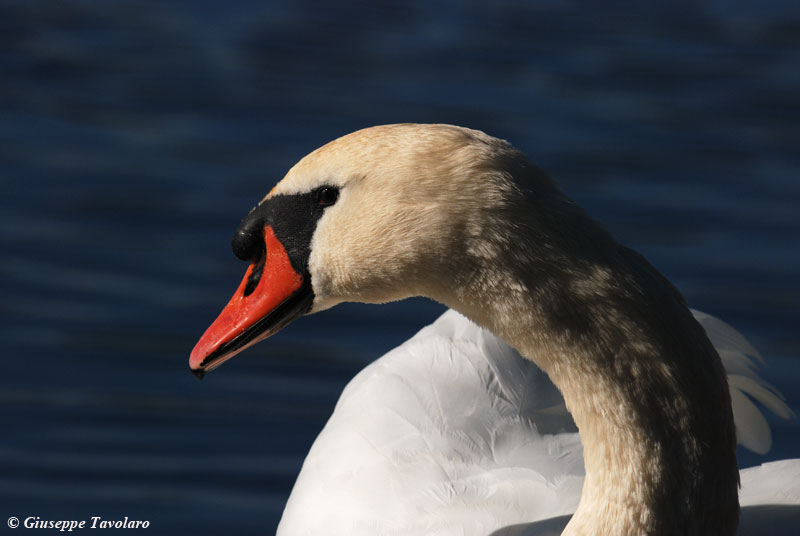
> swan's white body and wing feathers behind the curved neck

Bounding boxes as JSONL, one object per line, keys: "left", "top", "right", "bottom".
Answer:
{"left": 278, "top": 310, "right": 800, "bottom": 536}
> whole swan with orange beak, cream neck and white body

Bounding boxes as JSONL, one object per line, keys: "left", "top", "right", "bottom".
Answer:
{"left": 190, "top": 124, "right": 800, "bottom": 535}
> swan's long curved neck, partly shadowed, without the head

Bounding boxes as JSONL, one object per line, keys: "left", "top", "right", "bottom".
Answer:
{"left": 433, "top": 187, "right": 739, "bottom": 535}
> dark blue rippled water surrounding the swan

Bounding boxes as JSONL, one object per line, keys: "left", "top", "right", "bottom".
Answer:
{"left": 0, "top": 0, "right": 800, "bottom": 535}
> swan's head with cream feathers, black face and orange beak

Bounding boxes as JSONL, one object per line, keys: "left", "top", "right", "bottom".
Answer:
{"left": 190, "top": 124, "right": 560, "bottom": 376}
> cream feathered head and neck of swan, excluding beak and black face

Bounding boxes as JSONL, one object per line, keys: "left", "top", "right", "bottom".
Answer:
{"left": 280, "top": 125, "right": 739, "bottom": 535}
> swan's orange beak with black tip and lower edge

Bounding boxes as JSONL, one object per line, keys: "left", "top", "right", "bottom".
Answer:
{"left": 189, "top": 225, "right": 314, "bottom": 378}
